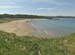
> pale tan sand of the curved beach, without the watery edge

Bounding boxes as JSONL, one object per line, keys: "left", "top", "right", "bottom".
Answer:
{"left": 0, "top": 19, "right": 51, "bottom": 38}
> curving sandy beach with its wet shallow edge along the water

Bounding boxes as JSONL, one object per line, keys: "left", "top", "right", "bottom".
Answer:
{"left": 0, "top": 19, "right": 73, "bottom": 38}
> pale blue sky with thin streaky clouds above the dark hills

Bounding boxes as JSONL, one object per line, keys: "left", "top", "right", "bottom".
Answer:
{"left": 0, "top": 0, "right": 75, "bottom": 16}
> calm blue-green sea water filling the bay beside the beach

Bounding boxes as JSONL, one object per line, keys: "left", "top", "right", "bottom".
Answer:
{"left": 31, "top": 18, "right": 75, "bottom": 36}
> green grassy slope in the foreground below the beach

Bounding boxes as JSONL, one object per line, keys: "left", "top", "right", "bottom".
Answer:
{"left": 0, "top": 31, "right": 75, "bottom": 55}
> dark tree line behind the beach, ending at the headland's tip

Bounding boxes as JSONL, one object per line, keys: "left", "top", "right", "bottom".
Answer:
{"left": 0, "top": 14, "right": 51, "bottom": 19}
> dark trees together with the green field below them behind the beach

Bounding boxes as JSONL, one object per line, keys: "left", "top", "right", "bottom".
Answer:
{"left": 0, "top": 14, "right": 51, "bottom": 23}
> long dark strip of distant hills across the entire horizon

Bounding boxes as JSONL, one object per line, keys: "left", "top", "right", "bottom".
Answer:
{"left": 0, "top": 14, "right": 75, "bottom": 19}
